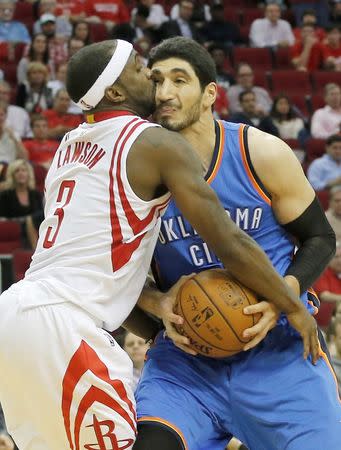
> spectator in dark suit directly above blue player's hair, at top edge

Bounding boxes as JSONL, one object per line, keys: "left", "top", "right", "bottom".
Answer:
{"left": 159, "top": 0, "right": 201, "bottom": 41}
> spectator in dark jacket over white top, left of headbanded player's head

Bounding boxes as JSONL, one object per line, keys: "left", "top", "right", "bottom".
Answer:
{"left": 16, "top": 62, "right": 53, "bottom": 113}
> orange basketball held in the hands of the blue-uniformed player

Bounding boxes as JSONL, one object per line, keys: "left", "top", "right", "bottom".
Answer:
{"left": 174, "top": 269, "right": 261, "bottom": 358}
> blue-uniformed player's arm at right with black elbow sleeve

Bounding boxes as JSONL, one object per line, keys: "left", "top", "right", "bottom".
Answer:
{"left": 248, "top": 128, "right": 335, "bottom": 293}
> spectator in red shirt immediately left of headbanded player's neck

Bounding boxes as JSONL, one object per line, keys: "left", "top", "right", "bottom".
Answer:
{"left": 43, "top": 89, "right": 83, "bottom": 140}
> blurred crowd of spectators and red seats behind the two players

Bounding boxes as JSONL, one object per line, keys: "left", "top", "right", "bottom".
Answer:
{"left": 0, "top": 0, "right": 341, "bottom": 449}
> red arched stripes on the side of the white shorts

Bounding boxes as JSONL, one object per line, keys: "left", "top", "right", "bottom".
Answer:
{"left": 62, "top": 340, "right": 136, "bottom": 450}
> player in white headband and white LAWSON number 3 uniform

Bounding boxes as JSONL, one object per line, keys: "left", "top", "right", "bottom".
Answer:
{"left": 0, "top": 40, "right": 318, "bottom": 450}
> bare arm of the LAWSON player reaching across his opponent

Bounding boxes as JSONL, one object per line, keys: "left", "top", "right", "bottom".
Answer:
{"left": 127, "top": 128, "right": 302, "bottom": 313}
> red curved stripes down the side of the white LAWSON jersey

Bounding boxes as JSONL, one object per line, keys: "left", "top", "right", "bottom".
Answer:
{"left": 110, "top": 119, "right": 169, "bottom": 270}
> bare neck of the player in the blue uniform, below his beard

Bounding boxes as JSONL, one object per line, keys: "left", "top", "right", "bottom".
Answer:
{"left": 180, "top": 110, "right": 216, "bottom": 171}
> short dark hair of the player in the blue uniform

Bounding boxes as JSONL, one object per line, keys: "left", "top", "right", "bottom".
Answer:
{"left": 148, "top": 36, "right": 217, "bottom": 90}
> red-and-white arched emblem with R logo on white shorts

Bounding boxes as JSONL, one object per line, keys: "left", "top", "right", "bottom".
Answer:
{"left": 62, "top": 341, "right": 136, "bottom": 450}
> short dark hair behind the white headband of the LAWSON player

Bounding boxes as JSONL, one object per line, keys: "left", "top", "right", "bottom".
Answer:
{"left": 66, "top": 40, "right": 116, "bottom": 103}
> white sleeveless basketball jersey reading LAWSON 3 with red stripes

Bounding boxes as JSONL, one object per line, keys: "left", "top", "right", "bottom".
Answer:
{"left": 24, "top": 112, "right": 170, "bottom": 331}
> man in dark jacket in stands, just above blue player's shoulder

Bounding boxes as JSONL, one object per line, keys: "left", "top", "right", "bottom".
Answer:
{"left": 230, "top": 89, "right": 278, "bottom": 136}
